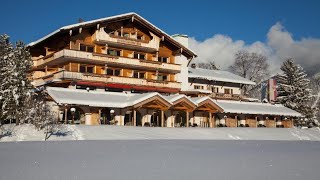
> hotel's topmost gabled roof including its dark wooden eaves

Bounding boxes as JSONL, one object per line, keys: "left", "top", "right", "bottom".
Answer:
{"left": 28, "top": 12, "right": 197, "bottom": 57}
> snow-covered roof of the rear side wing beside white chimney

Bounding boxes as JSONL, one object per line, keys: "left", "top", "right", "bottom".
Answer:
{"left": 188, "top": 68, "right": 256, "bottom": 85}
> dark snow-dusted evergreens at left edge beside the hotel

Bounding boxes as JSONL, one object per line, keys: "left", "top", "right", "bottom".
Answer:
{"left": 0, "top": 35, "right": 32, "bottom": 124}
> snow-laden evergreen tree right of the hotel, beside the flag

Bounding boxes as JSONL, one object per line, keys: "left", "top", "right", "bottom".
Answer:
{"left": 277, "top": 59, "right": 313, "bottom": 125}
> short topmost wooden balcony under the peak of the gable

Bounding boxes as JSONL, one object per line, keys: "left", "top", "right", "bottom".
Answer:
{"left": 92, "top": 29, "right": 160, "bottom": 52}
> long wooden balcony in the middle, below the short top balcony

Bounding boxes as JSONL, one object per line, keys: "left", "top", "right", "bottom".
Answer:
{"left": 34, "top": 49, "right": 181, "bottom": 73}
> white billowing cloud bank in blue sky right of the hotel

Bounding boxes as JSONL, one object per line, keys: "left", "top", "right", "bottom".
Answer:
{"left": 189, "top": 23, "right": 320, "bottom": 75}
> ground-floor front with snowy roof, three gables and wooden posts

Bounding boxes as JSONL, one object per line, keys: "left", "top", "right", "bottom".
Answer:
{"left": 47, "top": 87, "right": 301, "bottom": 128}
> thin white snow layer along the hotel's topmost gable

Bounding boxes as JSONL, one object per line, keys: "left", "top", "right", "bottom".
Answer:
{"left": 28, "top": 12, "right": 197, "bottom": 56}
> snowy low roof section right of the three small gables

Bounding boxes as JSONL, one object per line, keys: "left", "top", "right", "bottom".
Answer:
{"left": 214, "top": 100, "right": 302, "bottom": 117}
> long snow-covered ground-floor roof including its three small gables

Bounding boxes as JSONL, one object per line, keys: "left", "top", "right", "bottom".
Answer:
{"left": 47, "top": 87, "right": 302, "bottom": 117}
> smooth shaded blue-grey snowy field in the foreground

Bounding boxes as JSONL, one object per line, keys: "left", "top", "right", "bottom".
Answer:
{"left": 0, "top": 140, "right": 320, "bottom": 180}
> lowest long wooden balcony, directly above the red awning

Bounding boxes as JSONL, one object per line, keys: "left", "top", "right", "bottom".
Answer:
{"left": 33, "top": 71, "right": 181, "bottom": 89}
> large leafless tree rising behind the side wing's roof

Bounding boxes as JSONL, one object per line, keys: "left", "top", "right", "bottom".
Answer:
{"left": 229, "top": 50, "right": 270, "bottom": 95}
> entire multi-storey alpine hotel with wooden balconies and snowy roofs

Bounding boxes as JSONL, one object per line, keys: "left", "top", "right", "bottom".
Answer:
{"left": 28, "top": 13, "right": 301, "bottom": 127}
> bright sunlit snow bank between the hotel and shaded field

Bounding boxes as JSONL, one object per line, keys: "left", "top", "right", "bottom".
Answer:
{"left": 0, "top": 125, "right": 320, "bottom": 141}
